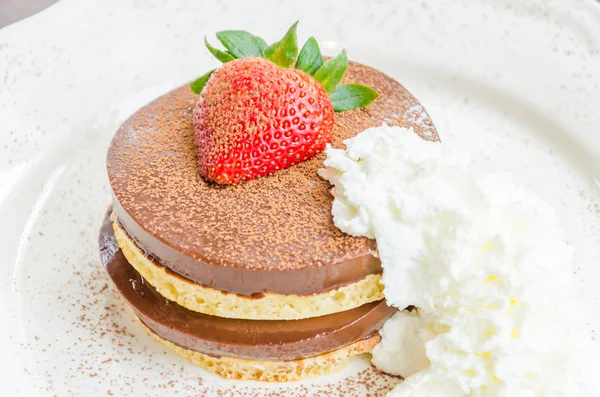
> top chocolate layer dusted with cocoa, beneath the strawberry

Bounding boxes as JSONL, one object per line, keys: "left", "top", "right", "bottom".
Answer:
{"left": 107, "top": 59, "right": 438, "bottom": 295}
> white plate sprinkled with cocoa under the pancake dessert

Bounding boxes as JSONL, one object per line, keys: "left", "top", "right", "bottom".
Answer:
{"left": 0, "top": 0, "right": 600, "bottom": 397}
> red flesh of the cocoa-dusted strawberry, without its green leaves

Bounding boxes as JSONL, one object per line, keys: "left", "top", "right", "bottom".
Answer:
{"left": 194, "top": 58, "right": 333, "bottom": 184}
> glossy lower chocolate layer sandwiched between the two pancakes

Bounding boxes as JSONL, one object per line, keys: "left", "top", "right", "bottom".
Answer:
{"left": 99, "top": 215, "right": 396, "bottom": 360}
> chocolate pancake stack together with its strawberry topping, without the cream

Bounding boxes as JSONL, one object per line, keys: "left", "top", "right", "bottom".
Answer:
{"left": 100, "top": 24, "right": 437, "bottom": 381}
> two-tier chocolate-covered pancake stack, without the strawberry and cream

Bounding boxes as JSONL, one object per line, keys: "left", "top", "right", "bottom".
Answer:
{"left": 100, "top": 63, "right": 437, "bottom": 381}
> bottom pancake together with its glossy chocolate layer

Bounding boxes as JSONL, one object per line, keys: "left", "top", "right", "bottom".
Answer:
{"left": 99, "top": 210, "right": 397, "bottom": 380}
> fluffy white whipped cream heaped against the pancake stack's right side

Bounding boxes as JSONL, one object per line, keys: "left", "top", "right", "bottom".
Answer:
{"left": 320, "top": 125, "right": 600, "bottom": 397}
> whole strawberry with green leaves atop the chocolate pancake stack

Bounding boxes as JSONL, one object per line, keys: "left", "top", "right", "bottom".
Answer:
{"left": 190, "top": 22, "right": 377, "bottom": 184}
